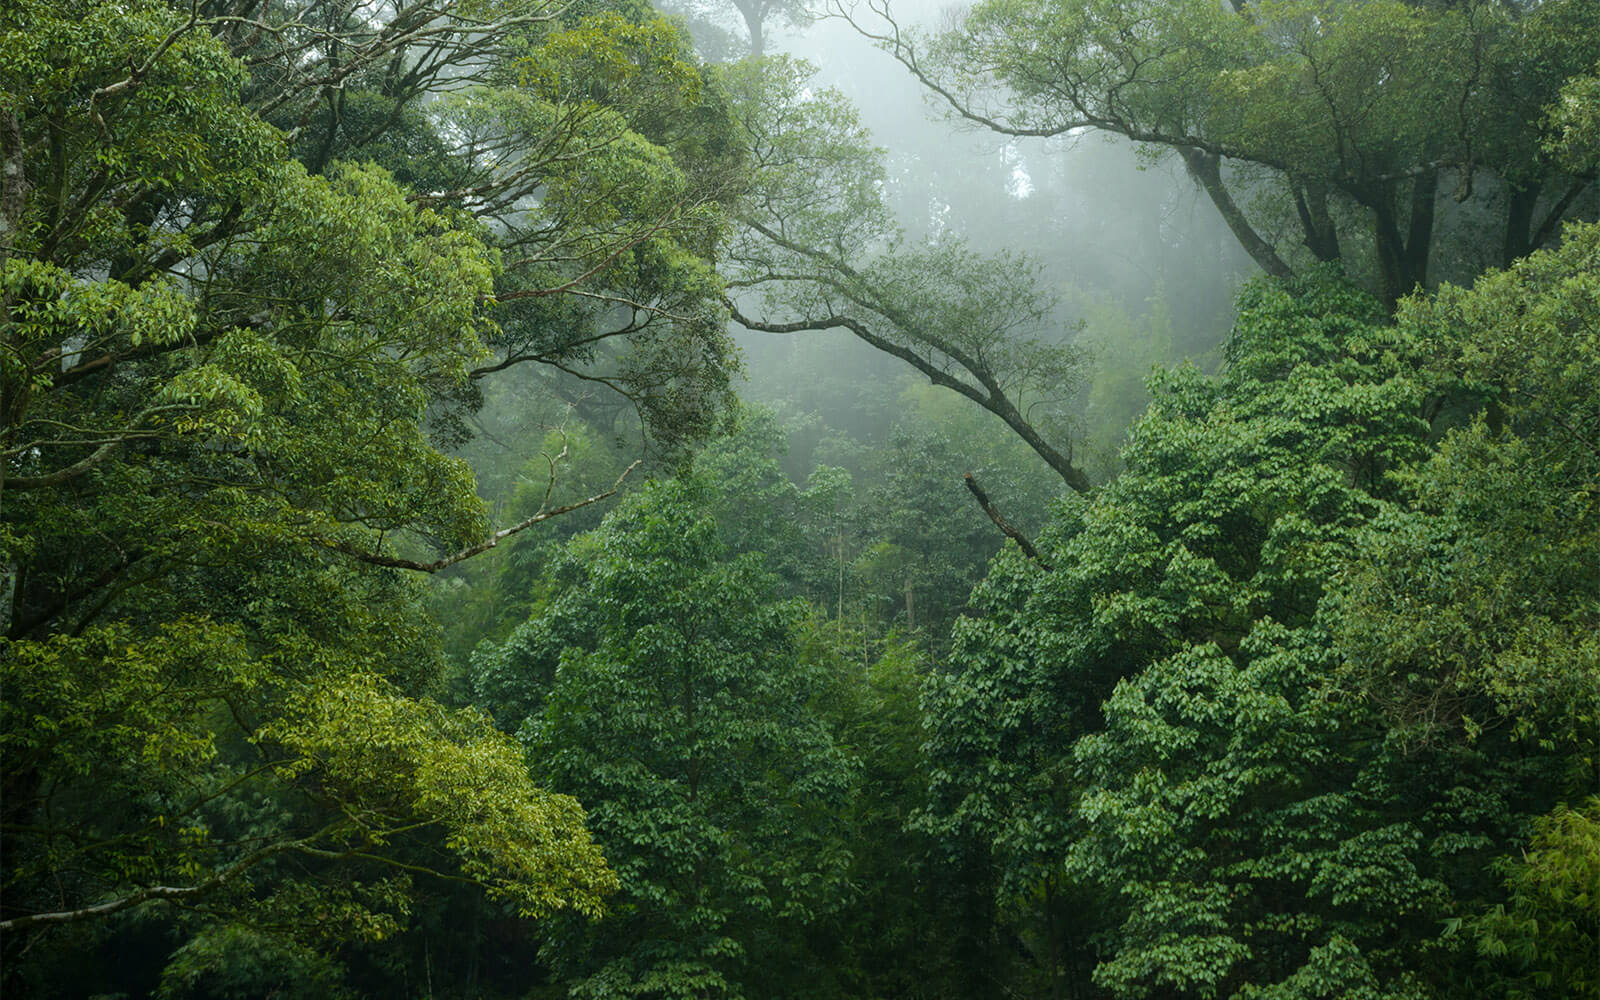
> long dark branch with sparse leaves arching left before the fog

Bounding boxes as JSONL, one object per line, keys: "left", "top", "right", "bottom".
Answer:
{"left": 725, "top": 56, "right": 1091, "bottom": 493}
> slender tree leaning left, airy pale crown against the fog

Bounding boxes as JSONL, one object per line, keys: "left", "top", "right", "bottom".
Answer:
{"left": 720, "top": 59, "right": 1090, "bottom": 491}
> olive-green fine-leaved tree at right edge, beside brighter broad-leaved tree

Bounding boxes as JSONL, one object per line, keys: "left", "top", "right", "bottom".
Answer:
{"left": 1341, "top": 226, "right": 1600, "bottom": 755}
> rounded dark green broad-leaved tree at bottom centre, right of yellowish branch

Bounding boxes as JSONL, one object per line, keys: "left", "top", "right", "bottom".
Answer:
{"left": 477, "top": 480, "right": 851, "bottom": 997}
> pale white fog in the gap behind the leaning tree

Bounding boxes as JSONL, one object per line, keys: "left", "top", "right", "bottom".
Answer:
{"left": 728, "top": 3, "right": 1254, "bottom": 472}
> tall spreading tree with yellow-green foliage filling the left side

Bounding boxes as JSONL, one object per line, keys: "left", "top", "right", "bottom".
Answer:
{"left": 0, "top": 2, "right": 764, "bottom": 994}
